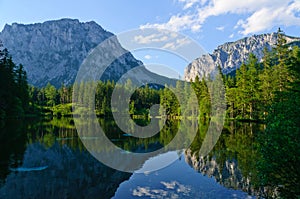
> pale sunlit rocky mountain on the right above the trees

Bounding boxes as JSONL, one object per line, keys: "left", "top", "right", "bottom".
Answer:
{"left": 184, "top": 33, "right": 300, "bottom": 81}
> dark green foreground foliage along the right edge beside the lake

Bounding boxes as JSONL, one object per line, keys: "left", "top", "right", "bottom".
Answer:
{"left": 258, "top": 28, "right": 300, "bottom": 198}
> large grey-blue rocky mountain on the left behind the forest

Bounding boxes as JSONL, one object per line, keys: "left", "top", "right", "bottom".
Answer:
{"left": 0, "top": 19, "right": 171, "bottom": 87}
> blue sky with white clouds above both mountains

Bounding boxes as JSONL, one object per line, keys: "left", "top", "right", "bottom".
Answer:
{"left": 0, "top": 0, "right": 300, "bottom": 74}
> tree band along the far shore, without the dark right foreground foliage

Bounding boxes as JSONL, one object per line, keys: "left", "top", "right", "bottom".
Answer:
{"left": 0, "top": 30, "right": 299, "bottom": 121}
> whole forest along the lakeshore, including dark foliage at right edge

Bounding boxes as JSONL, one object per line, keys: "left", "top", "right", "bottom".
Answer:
{"left": 0, "top": 29, "right": 300, "bottom": 198}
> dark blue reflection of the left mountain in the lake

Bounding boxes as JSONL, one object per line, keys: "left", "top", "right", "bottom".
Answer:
{"left": 0, "top": 143, "right": 131, "bottom": 198}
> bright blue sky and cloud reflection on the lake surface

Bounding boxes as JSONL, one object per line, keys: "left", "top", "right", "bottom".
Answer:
{"left": 113, "top": 152, "right": 254, "bottom": 199}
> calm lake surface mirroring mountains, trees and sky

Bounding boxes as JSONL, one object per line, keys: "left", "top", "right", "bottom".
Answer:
{"left": 0, "top": 118, "right": 262, "bottom": 199}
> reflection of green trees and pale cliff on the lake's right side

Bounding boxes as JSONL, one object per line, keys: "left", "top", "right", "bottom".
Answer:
{"left": 185, "top": 122, "right": 263, "bottom": 195}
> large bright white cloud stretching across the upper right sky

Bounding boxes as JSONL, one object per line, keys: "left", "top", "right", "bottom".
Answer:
{"left": 141, "top": 0, "right": 300, "bottom": 35}
